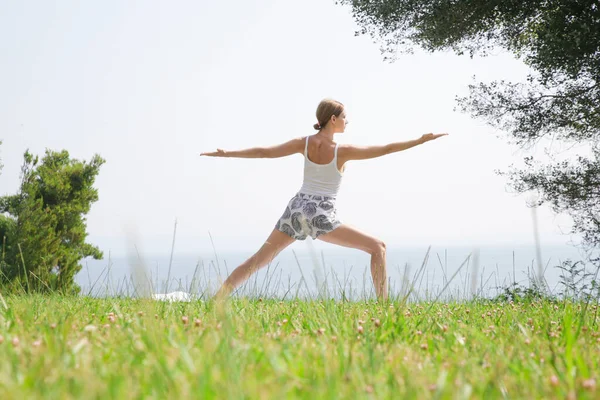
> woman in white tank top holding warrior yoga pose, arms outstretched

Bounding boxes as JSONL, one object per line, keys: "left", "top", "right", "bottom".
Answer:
{"left": 200, "top": 99, "right": 447, "bottom": 300}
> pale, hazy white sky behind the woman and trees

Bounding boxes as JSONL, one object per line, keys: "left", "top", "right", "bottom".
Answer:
{"left": 0, "top": 0, "right": 576, "bottom": 254}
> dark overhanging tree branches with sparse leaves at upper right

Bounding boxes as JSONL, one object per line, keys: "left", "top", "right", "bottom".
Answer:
{"left": 340, "top": 0, "right": 600, "bottom": 249}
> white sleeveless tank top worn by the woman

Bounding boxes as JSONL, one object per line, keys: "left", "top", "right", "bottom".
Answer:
{"left": 300, "top": 136, "right": 342, "bottom": 197}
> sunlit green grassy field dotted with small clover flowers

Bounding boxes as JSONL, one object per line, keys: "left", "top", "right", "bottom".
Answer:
{"left": 0, "top": 295, "right": 600, "bottom": 399}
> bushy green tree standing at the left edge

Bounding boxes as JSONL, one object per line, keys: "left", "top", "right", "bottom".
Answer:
{"left": 0, "top": 150, "right": 104, "bottom": 293}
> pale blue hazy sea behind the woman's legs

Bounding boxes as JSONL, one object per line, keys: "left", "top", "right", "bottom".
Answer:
{"left": 75, "top": 240, "right": 597, "bottom": 301}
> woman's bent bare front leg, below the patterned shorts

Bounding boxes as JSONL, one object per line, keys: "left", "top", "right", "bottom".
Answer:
{"left": 318, "top": 224, "right": 388, "bottom": 300}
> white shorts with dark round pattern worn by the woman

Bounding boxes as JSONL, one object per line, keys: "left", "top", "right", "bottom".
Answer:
{"left": 275, "top": 193, "right": 342, "bottom": 240}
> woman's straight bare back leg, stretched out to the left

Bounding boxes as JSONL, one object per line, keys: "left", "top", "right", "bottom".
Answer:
{"left": 215, "top": 229, "right": 296, "bottom": 299}
